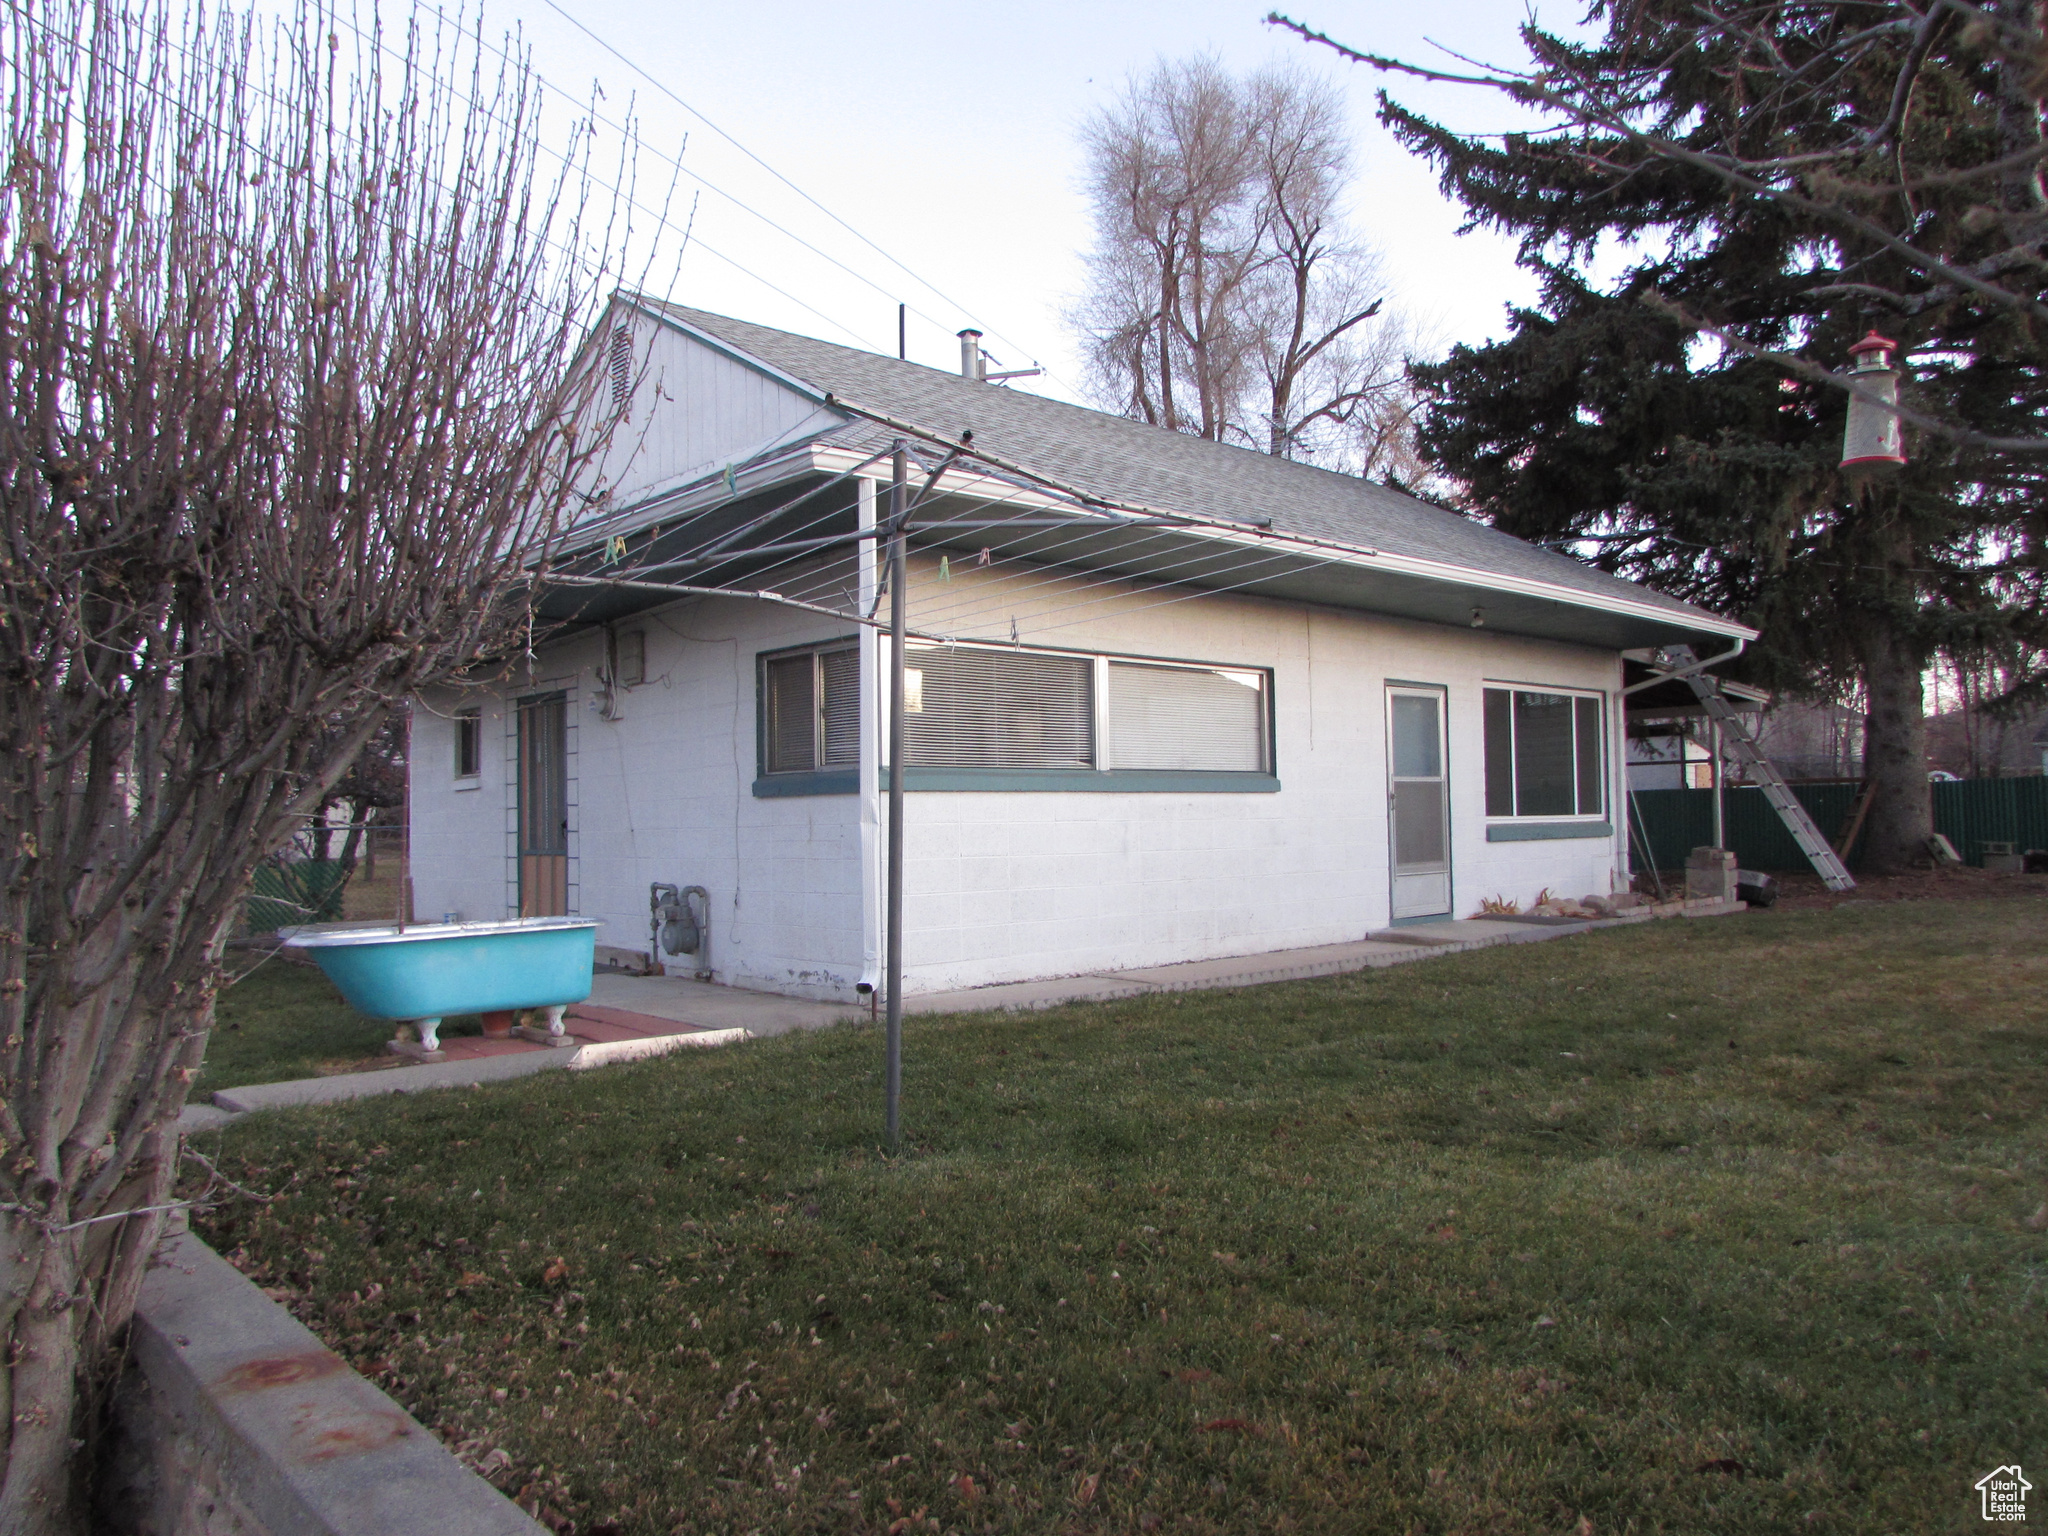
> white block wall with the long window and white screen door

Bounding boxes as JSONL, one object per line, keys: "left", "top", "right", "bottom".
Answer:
{"left": 888, "top": 571, "right": 1622, "bottom": 991}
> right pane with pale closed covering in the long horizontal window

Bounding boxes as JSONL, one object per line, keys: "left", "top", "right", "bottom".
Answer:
{"left": 1104, "top": 662, "right": 1268, "bottom": 774}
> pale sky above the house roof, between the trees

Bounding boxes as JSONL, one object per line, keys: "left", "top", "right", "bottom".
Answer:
{"left": 483, "top": 0, "right": 1579, "bottom": 399}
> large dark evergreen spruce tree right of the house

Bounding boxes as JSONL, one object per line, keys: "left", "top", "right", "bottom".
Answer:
{"left": 1382, "top": 0, "right": 2048, "bottom": 870}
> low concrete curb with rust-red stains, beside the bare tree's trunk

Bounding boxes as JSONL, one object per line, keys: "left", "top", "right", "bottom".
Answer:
{"left": 123, "top": 1233, "right": 545, "bottom": 1536}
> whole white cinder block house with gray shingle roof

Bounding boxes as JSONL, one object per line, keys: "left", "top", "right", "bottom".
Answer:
{"left": 410, "top": 299, "right": 1751, "bottom": 999}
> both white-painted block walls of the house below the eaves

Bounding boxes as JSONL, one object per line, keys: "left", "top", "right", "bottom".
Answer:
{"left": 412, "top": 573, "right": 1622, "bottom": 1001}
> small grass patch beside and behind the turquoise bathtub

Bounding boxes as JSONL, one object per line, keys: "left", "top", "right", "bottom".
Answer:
{"left": 204, "top": 956, "right": 483, "bottom": 1100}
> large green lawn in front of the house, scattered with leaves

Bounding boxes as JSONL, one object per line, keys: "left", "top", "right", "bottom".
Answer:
{"left": 201, "top": 899, "right": 2048, "bottom": 1536}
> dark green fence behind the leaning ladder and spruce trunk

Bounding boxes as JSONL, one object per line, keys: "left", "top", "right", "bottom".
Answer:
{"left": 1628, "top": 774, "right": 2048, "bottom": 870}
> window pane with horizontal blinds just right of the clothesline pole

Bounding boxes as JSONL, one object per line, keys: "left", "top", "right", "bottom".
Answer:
{"left": 903, "top": 645, "right": 1096, "bottom": 768}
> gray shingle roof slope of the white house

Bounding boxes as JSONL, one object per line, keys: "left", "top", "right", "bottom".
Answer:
{"left": 639, "top": 297, "right": 1726, "bottom": 623}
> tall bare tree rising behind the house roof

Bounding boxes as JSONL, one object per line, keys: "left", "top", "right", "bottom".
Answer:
{"left": 1077, "top": 57, "right": 1405, "bottom": 473}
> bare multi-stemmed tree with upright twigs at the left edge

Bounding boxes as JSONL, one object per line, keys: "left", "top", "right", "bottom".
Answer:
{"left": 0, "top": 0, "right": 626, "bottom": 1532}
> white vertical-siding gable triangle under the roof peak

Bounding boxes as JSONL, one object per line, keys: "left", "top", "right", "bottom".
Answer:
{"left": 596, "top": 309, "right": 846, "bottom": 510}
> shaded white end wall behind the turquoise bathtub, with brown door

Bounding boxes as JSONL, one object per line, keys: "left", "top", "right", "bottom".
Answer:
{"left": 410, "top": 600, "right": 862, "bottom": 997}
